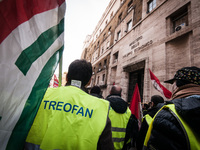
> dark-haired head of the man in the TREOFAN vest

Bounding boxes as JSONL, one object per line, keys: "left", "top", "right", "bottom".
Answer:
{"left": 67, "top": 59, "right": 92, "bottom": 86}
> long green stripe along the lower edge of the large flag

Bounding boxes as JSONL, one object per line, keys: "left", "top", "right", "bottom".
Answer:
{"left": 6, "top": 46, "right": 64, "bottom": 150}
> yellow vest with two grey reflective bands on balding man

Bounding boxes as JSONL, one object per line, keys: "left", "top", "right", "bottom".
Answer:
{"left": 109, "top": 107, "right": 131, "bottom": 149}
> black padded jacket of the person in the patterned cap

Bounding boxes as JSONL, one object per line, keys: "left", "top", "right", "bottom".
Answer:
{"left": 147, "top": 95, "right": 200, "bottom": 150}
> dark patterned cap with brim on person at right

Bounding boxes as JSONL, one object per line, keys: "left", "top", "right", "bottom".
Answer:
{"left": 164, "top": 66, "right": 200, "bottom": 87}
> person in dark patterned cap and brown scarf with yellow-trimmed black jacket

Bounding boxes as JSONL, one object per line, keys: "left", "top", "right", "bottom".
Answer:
{"left": 144, "top": 67, "right": 200, "bottom": 150}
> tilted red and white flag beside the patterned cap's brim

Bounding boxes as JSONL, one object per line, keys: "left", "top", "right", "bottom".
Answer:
{"left": 149, "top": 69, "right": 172, "bottom": 98}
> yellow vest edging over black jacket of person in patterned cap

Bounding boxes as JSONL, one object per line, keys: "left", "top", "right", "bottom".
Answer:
{"left": 144, "top": 104, "right": 200, "bottom": 150}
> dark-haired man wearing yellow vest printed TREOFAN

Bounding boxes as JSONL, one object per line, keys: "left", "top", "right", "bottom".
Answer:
{"left": 25, "top": 60, "right": 114, "bottom": 150}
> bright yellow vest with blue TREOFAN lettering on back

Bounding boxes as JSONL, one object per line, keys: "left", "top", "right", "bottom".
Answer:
{"left": 26, "top": 86, "right": 109, "bottom": 150}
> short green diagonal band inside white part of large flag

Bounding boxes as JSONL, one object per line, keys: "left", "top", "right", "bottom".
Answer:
{"left": 15, "top": 18, "right": 64, "bottom": 75}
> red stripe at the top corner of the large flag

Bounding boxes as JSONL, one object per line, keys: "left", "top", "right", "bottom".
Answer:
{"left": 0, "top": 0, "right": 65, "bottom": 43}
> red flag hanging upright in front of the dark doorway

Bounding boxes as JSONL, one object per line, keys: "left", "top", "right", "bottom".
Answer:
{"left": 129, "top": 83, "right": 142, "bottom": 125}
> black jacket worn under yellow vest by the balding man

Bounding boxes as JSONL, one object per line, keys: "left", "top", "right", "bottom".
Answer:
{"left": 106, "top": 95, "right": 138, "bottom": 149}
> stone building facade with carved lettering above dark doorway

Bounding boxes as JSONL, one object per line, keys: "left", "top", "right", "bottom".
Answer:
{"left": 81, "top": 0, "right": 200, "bottom": 103}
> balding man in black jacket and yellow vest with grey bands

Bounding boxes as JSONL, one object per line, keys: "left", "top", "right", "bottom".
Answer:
{"left": 106, "top": 85, "right": 138, "bottom": 150}
